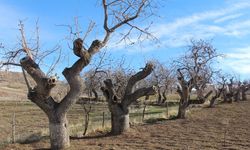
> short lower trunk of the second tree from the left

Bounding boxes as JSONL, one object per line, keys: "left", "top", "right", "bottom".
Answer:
{"left": 111, "top": 105, "right": 129, "bottom": 135}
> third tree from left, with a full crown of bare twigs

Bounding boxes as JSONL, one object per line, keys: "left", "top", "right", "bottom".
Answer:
{"left": 174, "top": 40, "right": 220, "bottom": 119}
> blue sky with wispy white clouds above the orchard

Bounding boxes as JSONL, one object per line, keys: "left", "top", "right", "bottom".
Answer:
{"left": 0, "top": 0, "right": 250, "bottom": 79}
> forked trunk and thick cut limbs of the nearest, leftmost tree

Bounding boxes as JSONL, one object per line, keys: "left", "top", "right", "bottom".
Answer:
{"left": 20, "top": 39, "right": 102, "bottom": 149}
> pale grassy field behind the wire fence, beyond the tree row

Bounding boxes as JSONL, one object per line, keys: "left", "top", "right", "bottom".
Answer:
{"left": 0, "top": 101, "right": 176, "bottom": 145}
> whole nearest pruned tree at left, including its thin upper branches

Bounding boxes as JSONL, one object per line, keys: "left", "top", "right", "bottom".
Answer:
{"left": 0, "top": 0, "right": 157, "bottom": 149}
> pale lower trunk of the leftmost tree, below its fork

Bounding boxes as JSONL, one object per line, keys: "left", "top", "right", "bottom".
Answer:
{"left": 49, "top": 114, "right": 70, "bottom": 150}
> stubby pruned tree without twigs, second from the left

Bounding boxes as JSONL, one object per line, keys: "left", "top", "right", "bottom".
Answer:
{"left": 101, "top": 63, "right": 156, "bottom": 135}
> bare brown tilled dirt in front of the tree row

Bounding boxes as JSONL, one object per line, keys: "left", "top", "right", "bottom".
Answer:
{"left": 5, "top": 100, "right": 250, "bottom": 150}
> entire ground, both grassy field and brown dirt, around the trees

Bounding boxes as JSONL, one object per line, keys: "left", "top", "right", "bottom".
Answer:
{"left": 0, "top": 71, "right": 250, "bottom": 150}
